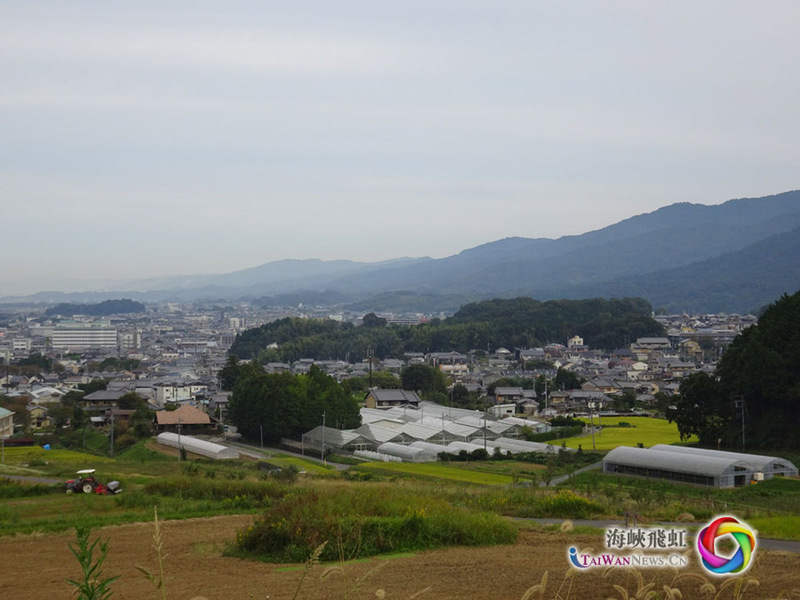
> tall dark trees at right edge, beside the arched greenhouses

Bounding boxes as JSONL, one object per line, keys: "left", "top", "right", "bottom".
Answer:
{"left": 668, "top": 292, "right": 800, "bottom": 449}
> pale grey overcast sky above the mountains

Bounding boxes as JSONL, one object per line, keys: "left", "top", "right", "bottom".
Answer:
{"left": 0, "top": 0, "right": 800, "bottom": 296}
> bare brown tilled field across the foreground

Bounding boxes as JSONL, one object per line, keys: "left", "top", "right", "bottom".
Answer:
{"left": 0, "top": 517, "right": 800, "bottom": 600}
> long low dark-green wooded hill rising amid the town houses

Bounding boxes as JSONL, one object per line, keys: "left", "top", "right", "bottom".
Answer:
{"left": 231, "top": 298, "right": 664, "bottom": 362}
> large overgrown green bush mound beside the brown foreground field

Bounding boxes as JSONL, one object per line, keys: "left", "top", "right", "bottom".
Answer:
{"left": 231, "top": 484, "right": 517, "bottom": 562}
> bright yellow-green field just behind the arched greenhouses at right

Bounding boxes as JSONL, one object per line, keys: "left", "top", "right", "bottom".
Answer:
{"left": 552, "top": 417, "right": 697, "bottom": 450}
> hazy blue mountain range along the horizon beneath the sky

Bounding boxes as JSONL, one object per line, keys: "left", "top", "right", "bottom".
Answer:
{"left": 6, "top": 191, "right": 800, "bottom": 312}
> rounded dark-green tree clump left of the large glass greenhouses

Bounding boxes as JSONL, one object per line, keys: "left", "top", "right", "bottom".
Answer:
{"left": 229, "top": 366, "right": 361, "bottom": 443}
